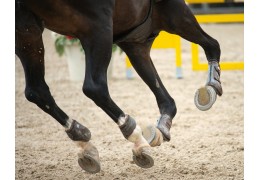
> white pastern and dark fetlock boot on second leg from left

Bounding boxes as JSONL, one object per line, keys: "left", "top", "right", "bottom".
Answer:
{"left": 118, "top": 115, "right": 150, "bottom": 153}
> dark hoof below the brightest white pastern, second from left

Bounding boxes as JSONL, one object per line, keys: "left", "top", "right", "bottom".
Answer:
{"left": 133, "top": 147, "right": 154, "bottom": 168}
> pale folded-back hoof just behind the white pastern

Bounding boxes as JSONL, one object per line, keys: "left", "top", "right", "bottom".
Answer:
{"left": 142, "top": 125, "right": 163, "bottom": 147}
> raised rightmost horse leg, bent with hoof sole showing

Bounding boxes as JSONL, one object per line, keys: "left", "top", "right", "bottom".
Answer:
{"left": 159, "top": 0, "right": 223, "bottom": 110}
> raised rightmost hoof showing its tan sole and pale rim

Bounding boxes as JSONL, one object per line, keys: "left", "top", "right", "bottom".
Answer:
{"left": 194, "top": 86, "right": 217, "bottom": 111}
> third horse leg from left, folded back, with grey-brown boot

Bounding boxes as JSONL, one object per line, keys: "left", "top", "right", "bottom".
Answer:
{"left": 119, "top": 40, "right": 177, "bottom": 146}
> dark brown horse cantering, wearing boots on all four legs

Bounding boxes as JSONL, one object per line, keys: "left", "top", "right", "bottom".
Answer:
{"left": 15, "top": 0, "right": 223, "bottom": 173}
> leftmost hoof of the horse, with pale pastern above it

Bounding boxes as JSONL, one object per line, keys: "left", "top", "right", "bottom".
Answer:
{"left": 78, "top": 143, "right": 101, "bottom": 174}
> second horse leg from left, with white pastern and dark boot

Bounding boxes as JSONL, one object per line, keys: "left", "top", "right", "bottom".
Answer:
{"left": 79, "top": 6, "right": 154, "bottom": 168}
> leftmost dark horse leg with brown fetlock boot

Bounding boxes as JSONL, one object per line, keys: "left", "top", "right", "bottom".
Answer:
{"left": 15, "top": 8, "right": 100, "bottom": 173}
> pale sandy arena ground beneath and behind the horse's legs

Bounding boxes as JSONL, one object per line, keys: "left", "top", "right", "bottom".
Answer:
{"left": 15, "top": 24, "right": 244, "bottom": 180}
